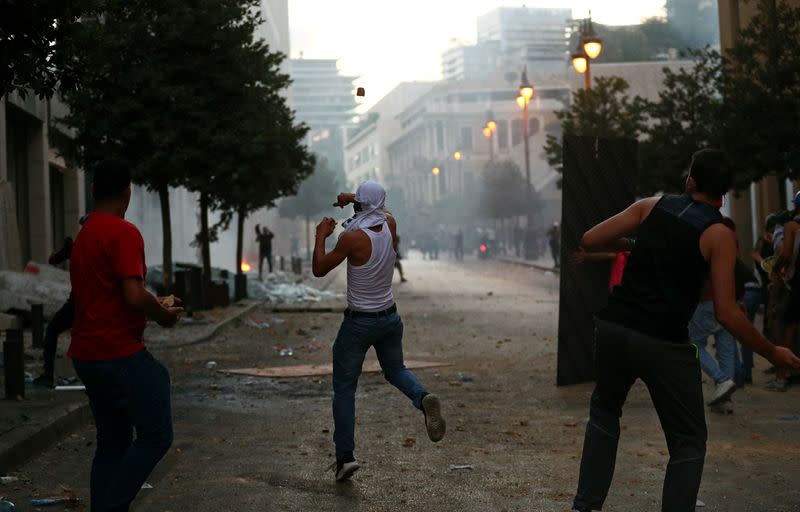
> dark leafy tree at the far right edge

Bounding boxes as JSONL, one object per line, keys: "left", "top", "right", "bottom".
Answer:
{"left": 723, "top": 0, "right": 800, "bottom": 197}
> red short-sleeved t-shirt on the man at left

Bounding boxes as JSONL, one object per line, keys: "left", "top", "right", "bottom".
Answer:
{"left": 68, "top": 213, "right": 147, "bottom": 361}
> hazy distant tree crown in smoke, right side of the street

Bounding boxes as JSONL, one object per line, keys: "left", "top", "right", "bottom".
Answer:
{"left": 479, "top": 160, "right": 541, "bottom": 219}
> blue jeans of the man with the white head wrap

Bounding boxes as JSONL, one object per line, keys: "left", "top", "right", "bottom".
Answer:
{"left": 333, "top": 313, "right": 428, "bottom": 459}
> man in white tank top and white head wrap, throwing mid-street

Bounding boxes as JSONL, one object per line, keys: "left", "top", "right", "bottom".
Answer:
{"left": 312, "top": 181, "right": 446, "bottom": 481}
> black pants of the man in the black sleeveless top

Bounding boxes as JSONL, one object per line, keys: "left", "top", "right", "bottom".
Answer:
{"left": 573, "top": 320, "right": 707, "bottom": 512}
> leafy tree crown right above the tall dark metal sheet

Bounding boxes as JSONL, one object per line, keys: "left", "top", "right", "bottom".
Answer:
{"left": 544, "top": 76, "right": 647, "bottom": 183}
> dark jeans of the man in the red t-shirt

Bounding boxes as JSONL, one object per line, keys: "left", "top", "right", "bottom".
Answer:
{"left": 73, "top": 350, "right": 172, "bottom": 512}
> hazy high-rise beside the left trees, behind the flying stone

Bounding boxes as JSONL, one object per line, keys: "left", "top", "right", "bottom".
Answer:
{"left": 289, "top": 59, "right": 356, "bottom": 171}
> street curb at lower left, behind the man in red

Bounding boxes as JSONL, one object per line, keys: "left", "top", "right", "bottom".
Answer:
{"left": 0, "top": 402, "right": 92, "bottom": 474}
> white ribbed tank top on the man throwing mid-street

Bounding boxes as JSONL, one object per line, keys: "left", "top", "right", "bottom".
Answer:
{"left": 347, "top": 222, "right": 397, "bottom": 313}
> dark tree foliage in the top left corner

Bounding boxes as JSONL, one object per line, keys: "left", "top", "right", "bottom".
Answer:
{"left": 0, "top": 0, "right": 100, "bottom": 98}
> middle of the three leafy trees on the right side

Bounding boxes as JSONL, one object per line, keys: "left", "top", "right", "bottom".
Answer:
{"left": 638, "top": 47, "right": 722, "bottom": 195}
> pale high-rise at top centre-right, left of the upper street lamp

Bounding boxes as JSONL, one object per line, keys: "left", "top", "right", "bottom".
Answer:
{"left": 478, "top": 7, "right": 572, "bottom": 77}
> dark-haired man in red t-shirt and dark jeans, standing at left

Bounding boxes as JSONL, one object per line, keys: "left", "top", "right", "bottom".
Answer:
{"left": 68, "top": 160, "right": 182, "bottom": 512}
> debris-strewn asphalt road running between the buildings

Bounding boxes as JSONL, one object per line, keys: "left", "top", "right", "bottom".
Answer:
{"left": 0, "top": 260, "right": 800, "bottom": 512}
